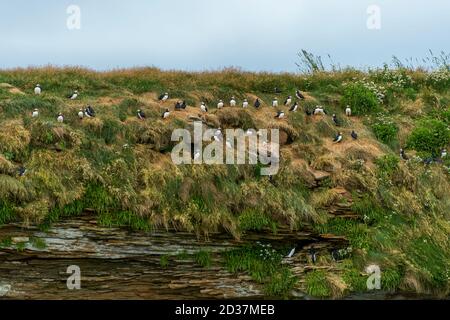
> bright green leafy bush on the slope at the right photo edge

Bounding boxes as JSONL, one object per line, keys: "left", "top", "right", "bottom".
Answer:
{"left": 407, "top": 119, "right": 450, "bottom": 155}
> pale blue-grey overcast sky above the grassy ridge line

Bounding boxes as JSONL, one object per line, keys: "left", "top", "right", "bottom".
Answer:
{"left": 0, "top": 0, "right": 450, "bottom": 72}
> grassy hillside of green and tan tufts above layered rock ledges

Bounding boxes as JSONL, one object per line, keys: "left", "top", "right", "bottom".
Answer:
{"left": 0, "top": 68, "right": 450, "bottom": 296}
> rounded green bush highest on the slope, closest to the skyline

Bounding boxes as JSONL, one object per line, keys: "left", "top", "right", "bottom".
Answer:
{"left": 341, "top": 83, "right": 379, "bottom": 115}
